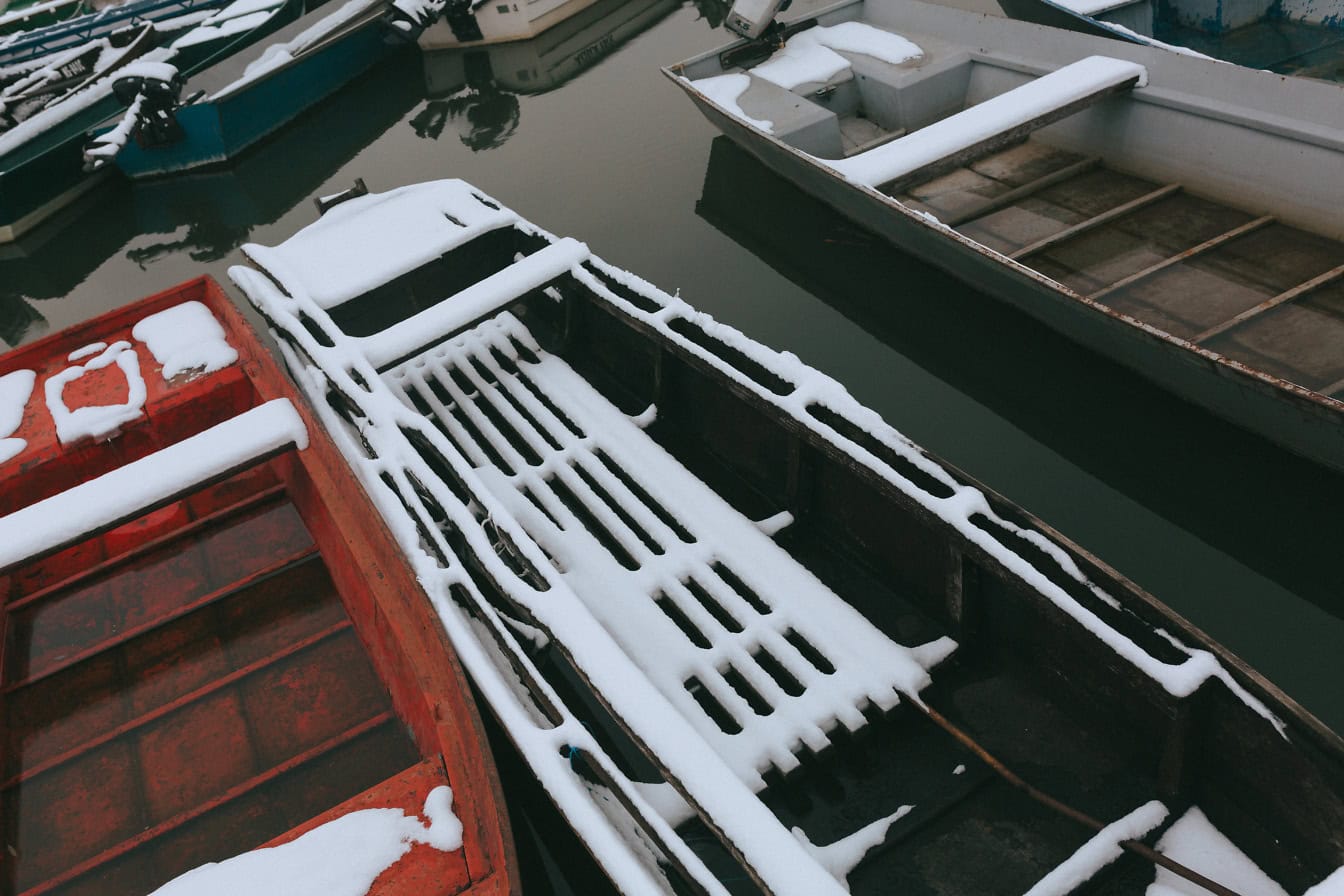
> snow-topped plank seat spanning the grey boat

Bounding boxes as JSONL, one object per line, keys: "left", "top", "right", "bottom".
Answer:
{"left": 827, "top": 56, "right": 1148, "bottom": 187}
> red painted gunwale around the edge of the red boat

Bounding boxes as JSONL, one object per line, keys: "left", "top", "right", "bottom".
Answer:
{"left": 0, "top": 275, "right": 519, "bottom": 896}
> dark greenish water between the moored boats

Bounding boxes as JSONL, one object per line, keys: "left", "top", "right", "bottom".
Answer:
{"left": 0, "top": 0, "right": 1344, "bottom": 752}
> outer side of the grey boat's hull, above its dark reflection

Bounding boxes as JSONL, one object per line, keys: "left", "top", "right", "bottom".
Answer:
{"left": 677, "top": 71, "right": 1344, "bottom": 470}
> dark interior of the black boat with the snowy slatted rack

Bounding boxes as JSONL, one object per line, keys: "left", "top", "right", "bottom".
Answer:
{"left": 259, "top": 200, "right": 1344, "bottom": 895}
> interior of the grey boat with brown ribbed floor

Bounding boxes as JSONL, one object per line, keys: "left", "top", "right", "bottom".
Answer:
{"left": 679, "top": 7, "right": 1344, "bottom": 398}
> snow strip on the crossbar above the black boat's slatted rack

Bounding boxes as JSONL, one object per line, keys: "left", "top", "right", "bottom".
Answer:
{"left": 359, "top": 238, "right": 589, "bottom": 367}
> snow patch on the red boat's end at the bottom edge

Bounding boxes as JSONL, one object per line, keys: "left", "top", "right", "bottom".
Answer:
{"left": 151, "top": 785, "right": 462, "bottom": 896}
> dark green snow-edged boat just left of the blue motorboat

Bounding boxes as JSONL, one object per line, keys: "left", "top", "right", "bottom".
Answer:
{"left": 0, "top": 0, "right": 304, "bottom": 243}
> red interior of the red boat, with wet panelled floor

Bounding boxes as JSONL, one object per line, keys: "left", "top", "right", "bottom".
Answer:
{"left": 0, "top": 281, "right": 488, "bottom": 896}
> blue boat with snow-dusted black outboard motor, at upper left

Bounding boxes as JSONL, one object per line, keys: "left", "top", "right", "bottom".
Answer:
{"left": 94, "top": 0, "right": 442, "bottom": 179}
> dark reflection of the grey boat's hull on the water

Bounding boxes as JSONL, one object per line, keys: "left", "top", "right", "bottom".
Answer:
{"left": 696, "top": 137, "right": 1344, "bottom": 619}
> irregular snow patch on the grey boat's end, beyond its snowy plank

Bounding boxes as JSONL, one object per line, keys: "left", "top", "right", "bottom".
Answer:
{"left": 758, "top": 21, "right": 923, "bottom": 90}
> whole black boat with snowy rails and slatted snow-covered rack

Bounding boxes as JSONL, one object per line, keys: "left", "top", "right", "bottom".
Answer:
{"left": 230, "top": 181, "right": 1344, "bottom": 896}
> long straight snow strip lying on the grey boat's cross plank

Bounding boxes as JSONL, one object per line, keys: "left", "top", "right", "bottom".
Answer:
{"left": 827, "top": 56, "right": 1146, "bottom": 187}
